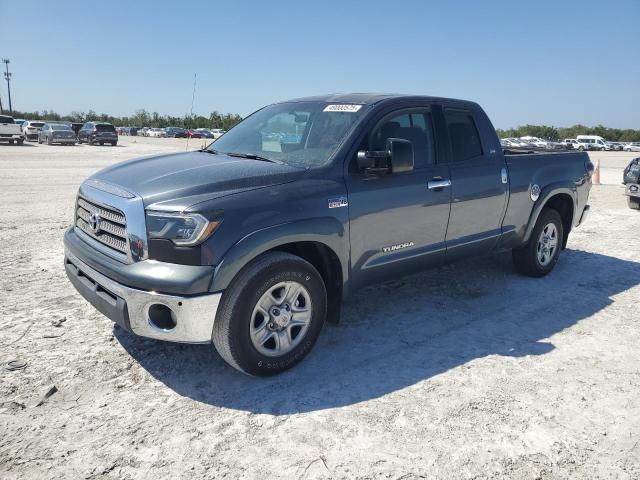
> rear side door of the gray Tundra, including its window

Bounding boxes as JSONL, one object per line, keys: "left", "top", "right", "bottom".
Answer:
{"left": 444, "top": 108, "right": 508, "bottom": 259}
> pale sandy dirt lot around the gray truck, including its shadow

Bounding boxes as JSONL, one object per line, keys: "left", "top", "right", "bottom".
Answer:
{"left": 0, "top": 138, "right": 640, "bottom": 479}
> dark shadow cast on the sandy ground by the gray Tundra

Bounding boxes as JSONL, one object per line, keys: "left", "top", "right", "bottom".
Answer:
{"left": 114, "top": 250, "right": 640, "bottom": 415}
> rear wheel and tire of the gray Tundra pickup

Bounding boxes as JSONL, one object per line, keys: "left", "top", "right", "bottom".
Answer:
{"left": 511, "top": 208, "right": 564, "bottom": 277}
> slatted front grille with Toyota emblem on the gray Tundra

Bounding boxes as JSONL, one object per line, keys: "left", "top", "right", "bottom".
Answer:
{"left": 76, "top": 197, "right": 129, "bottom": 255}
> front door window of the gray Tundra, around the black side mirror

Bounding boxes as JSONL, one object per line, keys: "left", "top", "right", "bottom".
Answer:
{"left": 369, "top": 111, "right": 435, "bottom": 169}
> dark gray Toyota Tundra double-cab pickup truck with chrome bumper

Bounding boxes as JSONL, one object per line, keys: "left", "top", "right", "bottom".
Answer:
{"left": 64, "top": 94, "right": 593, "bottom": 376}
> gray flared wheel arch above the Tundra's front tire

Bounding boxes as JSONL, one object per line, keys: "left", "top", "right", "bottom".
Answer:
{"left": 209, "top": 217, "right": 349, "bottom": 292}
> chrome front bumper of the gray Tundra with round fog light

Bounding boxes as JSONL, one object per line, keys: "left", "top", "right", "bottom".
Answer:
{"left": 64, "top": 249, "right": 222, "bottom": 343}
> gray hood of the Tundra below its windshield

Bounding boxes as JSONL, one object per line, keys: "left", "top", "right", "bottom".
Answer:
{"left": 91, "top": 151, "right": 305, "bottom": 211}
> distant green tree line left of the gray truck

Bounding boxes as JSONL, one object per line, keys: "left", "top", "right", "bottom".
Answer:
{"left": 6, "top": 109, "right": 242, "bottom": 130}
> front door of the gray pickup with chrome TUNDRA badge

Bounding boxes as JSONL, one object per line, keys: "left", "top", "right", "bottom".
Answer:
{"left": 346, "top": 106, "right": 450, "bottom": 285}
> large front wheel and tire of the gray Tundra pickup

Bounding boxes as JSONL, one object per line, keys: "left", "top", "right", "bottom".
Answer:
{"left": 213, "top": 252, "right": 327, "bottom": 376}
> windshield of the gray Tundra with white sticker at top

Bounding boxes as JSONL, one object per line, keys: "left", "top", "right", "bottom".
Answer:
{"left": 208, "top": 102, "right": 364, "bottom": 168}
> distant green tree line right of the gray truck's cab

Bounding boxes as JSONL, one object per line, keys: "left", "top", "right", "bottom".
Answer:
{"left": 496, "top": 125, "right": 640, "bottom": 142}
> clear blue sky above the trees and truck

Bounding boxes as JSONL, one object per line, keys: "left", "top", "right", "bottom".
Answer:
{"left": 0, "top": 0, "right": 640, "bottom": 129}
